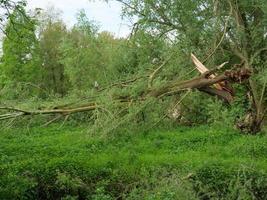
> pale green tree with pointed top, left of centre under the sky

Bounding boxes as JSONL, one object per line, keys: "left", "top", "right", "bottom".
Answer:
{"left": 61, "top": 11, "right": 100, "bottom": 91}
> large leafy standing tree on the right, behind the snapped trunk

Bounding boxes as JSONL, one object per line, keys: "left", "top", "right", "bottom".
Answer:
{"left": 122, "top": 0, "right": 267, "bottom": 132}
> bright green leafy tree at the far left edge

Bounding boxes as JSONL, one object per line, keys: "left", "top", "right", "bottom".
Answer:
{"left": 0, "top": 9, "right": 41, "bottom": 99}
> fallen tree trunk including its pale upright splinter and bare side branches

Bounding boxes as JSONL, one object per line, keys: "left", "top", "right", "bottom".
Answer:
{"left": 0, "top": 54, "right": 251, "bottom": 128}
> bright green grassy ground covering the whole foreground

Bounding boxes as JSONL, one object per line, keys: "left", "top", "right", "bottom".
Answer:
{"left": 0, "top": 125, "right": 267, "bottom": 200}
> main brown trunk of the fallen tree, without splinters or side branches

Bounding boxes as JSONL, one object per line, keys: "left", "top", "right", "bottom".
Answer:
{"left": 0, "top": 68, "right": 251, "bottom": 120}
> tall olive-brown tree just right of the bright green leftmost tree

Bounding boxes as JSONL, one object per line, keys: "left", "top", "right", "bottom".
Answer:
{"left": 39, "top": 10, "right": 67, "bottom": 96}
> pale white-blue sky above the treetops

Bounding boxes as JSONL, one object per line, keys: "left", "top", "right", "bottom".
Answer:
{"left": 27, "top": 0, "right": 133, "bottom": 37}
